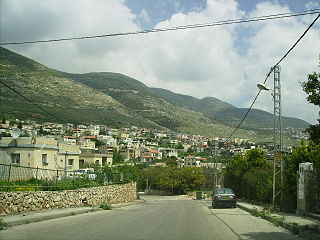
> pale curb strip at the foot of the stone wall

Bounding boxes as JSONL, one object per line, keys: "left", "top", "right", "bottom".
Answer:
{"left": 3, "top": 200, "right": 145, "bottom": 227}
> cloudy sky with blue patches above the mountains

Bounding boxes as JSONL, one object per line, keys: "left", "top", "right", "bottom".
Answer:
{"left": 0, "top": 0, "right": 320, "bottom": 123}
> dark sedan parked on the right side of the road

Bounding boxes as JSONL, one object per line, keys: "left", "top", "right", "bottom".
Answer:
{"left": 212, "top": 188, "right": 237, "bottom": 208}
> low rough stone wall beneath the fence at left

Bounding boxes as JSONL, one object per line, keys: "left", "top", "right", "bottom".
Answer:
{"left": 0, "top": 183, "right": 137, "bottom": 216}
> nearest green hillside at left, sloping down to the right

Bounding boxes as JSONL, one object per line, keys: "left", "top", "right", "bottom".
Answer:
{"left": 0, "top": 48, "right": 161, "bottom": 128}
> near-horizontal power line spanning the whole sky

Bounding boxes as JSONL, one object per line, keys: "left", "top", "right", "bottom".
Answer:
{"left": 0, "top": 9, "right": 320, "bottom": 46}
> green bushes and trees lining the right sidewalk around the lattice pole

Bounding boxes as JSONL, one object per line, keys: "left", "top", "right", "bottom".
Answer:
{"left": 225, "top": 69, "right": 320, "bottom": 212}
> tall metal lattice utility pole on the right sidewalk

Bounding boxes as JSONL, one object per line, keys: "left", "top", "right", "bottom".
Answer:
{"left": 272, "top": 66, "right": 283, "bottom": 209}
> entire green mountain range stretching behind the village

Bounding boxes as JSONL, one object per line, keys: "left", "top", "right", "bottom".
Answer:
{"left": 0, "top": 48, "right": 308, "bottom": 141}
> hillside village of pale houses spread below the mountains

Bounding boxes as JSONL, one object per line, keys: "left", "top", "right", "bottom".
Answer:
{"left": 0, "top": 117, "right": 304, "bottom": 171}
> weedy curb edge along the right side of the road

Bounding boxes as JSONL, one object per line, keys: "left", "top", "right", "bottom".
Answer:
{"left": 237, "top": 203, "right": 320, "bottom": 240}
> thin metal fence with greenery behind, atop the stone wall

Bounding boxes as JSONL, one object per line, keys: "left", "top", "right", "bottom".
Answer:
{"left": 0, "top": 164, "right": 135, "bottom": 191}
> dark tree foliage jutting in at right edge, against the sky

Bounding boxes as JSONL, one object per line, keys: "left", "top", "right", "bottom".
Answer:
{"left": 301, "top": 72, "right": 320, "bottom": 144}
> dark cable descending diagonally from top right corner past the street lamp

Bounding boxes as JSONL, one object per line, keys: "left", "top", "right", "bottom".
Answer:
{"left": 226, "top": 14, "right": 320, "bottom": 141}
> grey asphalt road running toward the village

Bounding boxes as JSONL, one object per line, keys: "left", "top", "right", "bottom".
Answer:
{"left": 0, "top": 196, "right": 299, "bottom": 240}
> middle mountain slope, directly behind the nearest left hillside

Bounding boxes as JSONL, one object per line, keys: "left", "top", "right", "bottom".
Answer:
{"left": 61, "top": 73, "right": 254, "bottom": 137}
